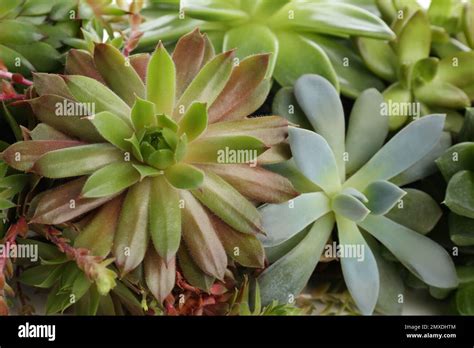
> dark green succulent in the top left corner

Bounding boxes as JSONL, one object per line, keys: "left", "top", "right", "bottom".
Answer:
{"left": 0, "top": 0, "right": 126, "bottom": 75}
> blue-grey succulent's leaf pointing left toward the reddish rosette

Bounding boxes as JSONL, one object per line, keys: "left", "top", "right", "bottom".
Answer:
{"left": 259, "top": 192, "right": 331, "bottom": 247}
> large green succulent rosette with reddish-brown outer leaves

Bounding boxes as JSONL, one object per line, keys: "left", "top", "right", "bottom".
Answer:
{"left": 3, "top": 30, "right": 296, "bottom": 302}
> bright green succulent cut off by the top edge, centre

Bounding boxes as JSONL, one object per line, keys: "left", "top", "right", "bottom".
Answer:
{"left": 135, "top": 0, "right": 394, "bottom": 97}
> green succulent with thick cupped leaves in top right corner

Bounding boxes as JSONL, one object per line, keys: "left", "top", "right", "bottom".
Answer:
{"left": 356, "top": 1, "right": 474, "bottom": 131}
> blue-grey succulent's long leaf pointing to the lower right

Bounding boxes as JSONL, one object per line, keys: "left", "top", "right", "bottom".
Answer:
{"left": 359, "top": 215, "right": 458, "bottom": 288}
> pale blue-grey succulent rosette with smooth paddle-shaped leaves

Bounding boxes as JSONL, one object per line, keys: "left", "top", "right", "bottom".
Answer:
{"left": 259, "top": 75, "right": 458, "bottom": 314}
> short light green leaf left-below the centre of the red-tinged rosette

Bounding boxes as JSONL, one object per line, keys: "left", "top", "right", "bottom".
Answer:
{"left": 82, "top": 162, "right": 140, "bottom": 198}
